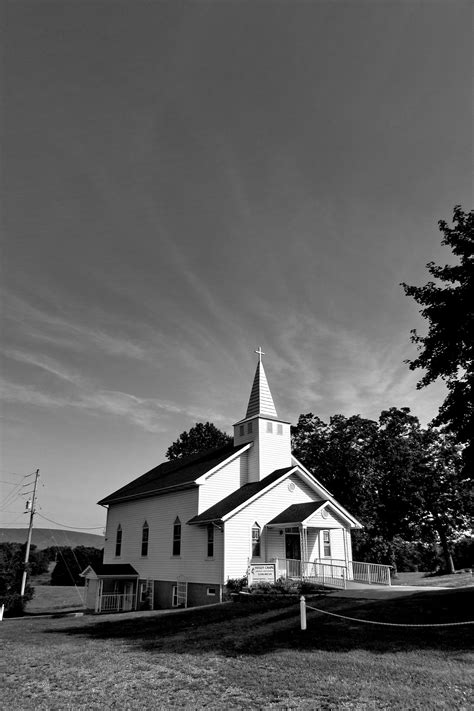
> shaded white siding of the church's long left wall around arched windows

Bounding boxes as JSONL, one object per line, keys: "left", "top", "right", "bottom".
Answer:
{"left": 104, "top": 488, "right": 223, "bottom": 584}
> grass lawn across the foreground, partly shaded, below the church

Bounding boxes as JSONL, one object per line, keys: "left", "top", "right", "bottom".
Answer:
{"left": 0, "top": 588, "right": 474, "bottom": 711}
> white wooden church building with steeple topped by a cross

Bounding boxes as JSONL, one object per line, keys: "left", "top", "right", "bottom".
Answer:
{"left": 83, "top": 349, "right": 370, "bottom": 612}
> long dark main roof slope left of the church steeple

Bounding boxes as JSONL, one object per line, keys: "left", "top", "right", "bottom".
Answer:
{"left": 98, "top": 444, "right": 249, "bottom": 506}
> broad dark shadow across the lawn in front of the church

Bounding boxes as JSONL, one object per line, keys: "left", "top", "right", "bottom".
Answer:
{"left": 56, "top": 589, "right": 474, "bottom": 657}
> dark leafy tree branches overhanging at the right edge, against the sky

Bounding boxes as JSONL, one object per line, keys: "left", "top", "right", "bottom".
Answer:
{"left": 402, "top": 205, "right": 474, "bottom": 476}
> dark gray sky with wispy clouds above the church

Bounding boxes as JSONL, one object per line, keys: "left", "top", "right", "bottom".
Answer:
{"left": 0, "top": 0, "right": 473, "bottom": 533}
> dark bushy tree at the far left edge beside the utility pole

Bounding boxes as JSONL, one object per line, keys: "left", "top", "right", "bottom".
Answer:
{"left": 0, "top": 543, "right": 34, "bottom": 617}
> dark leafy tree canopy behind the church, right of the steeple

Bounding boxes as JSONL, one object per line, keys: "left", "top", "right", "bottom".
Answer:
{"left": 292, "top": 407, "right": 469, "bottom": 569}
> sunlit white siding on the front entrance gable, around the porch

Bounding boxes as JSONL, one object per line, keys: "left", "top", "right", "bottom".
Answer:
{"left": 224, "top": 474, "right": 318, "bottom": 579}
